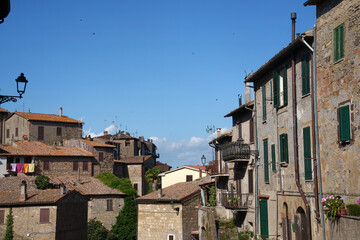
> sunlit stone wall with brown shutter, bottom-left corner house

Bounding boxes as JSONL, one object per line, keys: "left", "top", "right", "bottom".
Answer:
{"left": 0, "top": 206, "right": 57, "bottom": 240}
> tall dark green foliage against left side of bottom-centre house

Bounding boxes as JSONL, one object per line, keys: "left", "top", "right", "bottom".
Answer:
{"left": 111, "top": 196, "right": 137, "bottom": 240}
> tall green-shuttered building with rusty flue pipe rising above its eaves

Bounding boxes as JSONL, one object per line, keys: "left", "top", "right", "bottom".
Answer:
{"left": 245, "top": 25, "right": 319, "bottom": 239}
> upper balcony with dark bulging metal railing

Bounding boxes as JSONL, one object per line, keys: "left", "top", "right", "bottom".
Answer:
{"left": 221, "top": 141, "right": 251, "bottom": 162}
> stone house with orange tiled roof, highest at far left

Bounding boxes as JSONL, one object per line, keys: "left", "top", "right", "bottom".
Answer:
{"left": 3, "top": 108, "right": 83, "bottom": 145}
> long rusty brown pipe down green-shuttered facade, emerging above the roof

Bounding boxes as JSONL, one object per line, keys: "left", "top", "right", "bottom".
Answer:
{"left": 291, "top": 13, "right": 312, "bottom": 240}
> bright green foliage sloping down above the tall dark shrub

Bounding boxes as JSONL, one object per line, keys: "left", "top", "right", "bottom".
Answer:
{"left": 96, "top": 172, "right": 137, "bottom": 199}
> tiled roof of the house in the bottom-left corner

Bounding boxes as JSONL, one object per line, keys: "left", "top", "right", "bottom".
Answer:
{"left": 0, "top": 188, "right": 76, "bottom": 205}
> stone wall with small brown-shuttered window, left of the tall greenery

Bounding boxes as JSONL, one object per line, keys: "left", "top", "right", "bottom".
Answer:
{"left": 88, "top": 196, "right": 124, "bottom": 230}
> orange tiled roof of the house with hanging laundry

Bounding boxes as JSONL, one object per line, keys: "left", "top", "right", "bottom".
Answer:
{"left": 0, "top": 141, "right": 93, "bottom": 157}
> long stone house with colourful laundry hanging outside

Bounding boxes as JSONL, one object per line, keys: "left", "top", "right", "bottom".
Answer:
{"left": 0, "top": 141, "right": 101, "bottom": 176}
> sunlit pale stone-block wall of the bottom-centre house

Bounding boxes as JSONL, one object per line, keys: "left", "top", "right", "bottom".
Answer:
{"left": 138, "top": 203, "right": 183, "bottom": 240}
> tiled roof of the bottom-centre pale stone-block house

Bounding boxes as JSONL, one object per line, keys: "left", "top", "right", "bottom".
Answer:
{"left": 136, "top": 179, "right": 213, "bottom": 203}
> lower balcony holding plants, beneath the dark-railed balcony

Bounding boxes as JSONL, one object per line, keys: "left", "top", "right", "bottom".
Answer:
{"left": 221, "top": 193, "right": 251, "bottom": 211}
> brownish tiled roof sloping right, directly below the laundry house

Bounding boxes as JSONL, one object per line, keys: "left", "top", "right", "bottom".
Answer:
{"left": 49, "top": 175, "right": 127, "bottom": 196}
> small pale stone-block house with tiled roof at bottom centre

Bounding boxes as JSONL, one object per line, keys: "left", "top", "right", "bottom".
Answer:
{"left": 135, "top": 181, "right": 212, "bottom": 240}
